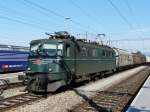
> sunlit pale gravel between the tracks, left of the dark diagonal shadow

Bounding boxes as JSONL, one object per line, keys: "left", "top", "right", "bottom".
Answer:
{"left": 8, "top": 91, "right": 82, "bottom": 112}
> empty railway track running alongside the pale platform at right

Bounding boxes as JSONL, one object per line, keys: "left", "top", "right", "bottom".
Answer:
{"left": 68, "top": 68, "right": 150, "bottom": 112}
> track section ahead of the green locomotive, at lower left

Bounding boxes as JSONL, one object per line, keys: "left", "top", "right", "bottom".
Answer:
{"left": 0, "top": 93, "right": 43, "bottom": 112}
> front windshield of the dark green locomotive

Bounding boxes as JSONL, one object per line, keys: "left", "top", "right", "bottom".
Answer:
{"left": 30, "top": 43, "right": 63, "bottom": 57}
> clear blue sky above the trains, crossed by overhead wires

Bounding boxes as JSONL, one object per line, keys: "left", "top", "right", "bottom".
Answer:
{"left": 0, "top": 0, "right": 150, "bottom": 53}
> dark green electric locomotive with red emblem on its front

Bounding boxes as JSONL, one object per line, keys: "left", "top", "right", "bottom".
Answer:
{"left": 19, "top": 32, "right": 116, "bottom": 92}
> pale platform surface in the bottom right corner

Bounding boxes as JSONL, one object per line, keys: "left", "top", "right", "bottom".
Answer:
{"left": 126, "top": 76, "right": 150, "bottom": 112}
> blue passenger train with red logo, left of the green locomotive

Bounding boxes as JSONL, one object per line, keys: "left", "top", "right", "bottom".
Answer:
{"left": 0, "top": 45, "right": 29, "bottom": 73}
